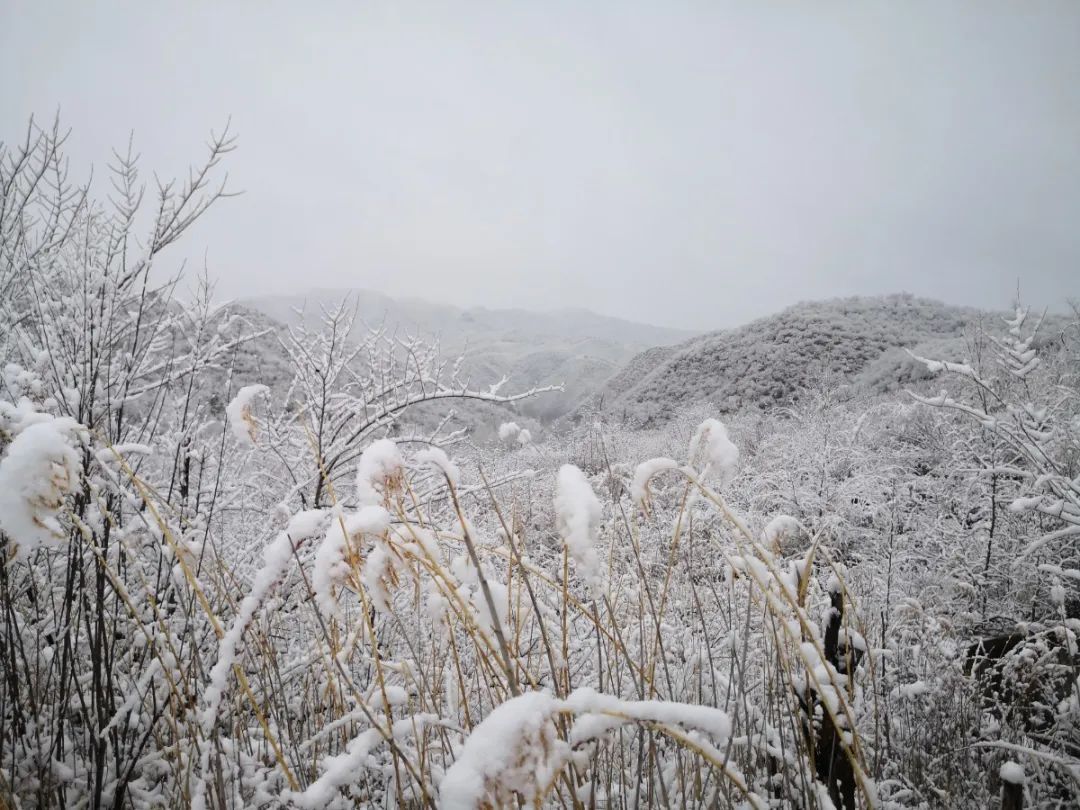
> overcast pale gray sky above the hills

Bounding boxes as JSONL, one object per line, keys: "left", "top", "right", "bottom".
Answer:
{"left": 0, "top": 0, "right": 1080, "bottom": 328}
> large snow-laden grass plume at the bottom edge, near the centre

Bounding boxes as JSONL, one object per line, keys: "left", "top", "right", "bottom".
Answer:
{"left": 438, "top": 691, "right": 566, "bottom": 810}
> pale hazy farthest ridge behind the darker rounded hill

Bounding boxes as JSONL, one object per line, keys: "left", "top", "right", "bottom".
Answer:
{"left": 233, "top": 289, "right": 693, "bottom": 421}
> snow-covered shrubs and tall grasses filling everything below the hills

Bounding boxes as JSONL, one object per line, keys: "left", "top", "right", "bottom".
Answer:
{"left": 0, "top": 115, "right": 1080, "bottom": 810}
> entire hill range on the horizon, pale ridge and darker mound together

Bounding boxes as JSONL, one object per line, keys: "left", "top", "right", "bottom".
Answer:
{"left": 212, "top": 291, "right": 1061, "bottom": 440}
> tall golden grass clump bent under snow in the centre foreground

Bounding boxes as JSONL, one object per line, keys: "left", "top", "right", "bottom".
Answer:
{"left": 181, "top": 422, "right": 876, "bottom": 808}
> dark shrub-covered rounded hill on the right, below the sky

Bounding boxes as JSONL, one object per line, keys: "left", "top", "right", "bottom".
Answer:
{"left": 571, "top": 295, "right": 986, "bottom": 426}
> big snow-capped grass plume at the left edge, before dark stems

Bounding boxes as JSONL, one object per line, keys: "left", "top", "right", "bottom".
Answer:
{"left": 0, "top": 415, "right": 80, "bottom": 558}
